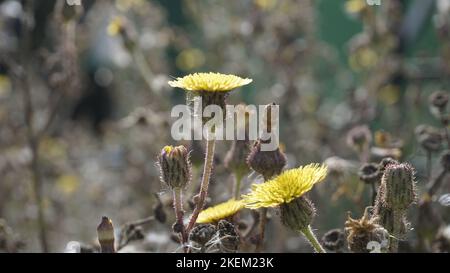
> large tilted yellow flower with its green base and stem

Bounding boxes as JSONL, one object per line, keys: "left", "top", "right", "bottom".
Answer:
{"left": 243, "top": 164, "right": 327, "bottom": 252}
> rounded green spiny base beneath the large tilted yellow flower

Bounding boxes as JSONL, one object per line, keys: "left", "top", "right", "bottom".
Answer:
{"left": 280, "top": 196, "right": 316, "bottom": 231}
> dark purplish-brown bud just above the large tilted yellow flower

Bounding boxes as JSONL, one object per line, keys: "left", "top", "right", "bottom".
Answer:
{"left": 247, "top": 140, "right": 287, "bottom": 180}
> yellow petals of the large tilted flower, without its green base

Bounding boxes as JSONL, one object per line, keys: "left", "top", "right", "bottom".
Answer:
{"left": 242, "top": 164, "right": 327, "bottom": 209}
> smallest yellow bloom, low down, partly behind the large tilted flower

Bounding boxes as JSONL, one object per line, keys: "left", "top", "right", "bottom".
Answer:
{"left": 197, "top": 199, "right": 244, "bottom": 224}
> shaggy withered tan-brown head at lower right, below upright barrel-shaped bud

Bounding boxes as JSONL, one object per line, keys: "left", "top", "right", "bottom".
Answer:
{"left": 345, "top": 207, "right": 389, "bottom": 253}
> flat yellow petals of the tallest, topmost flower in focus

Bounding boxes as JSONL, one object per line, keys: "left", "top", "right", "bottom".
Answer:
{"left": 169, "top": 72, "right": 253, "bottom": 92}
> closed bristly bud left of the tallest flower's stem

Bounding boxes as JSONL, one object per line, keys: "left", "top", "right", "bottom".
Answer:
{"left": 158, "top": 146, "right": 191, "bottom": 189}
